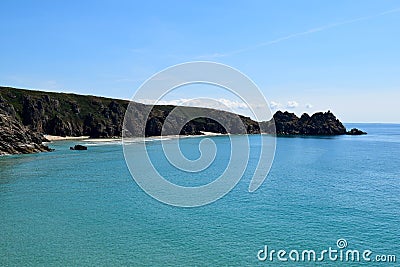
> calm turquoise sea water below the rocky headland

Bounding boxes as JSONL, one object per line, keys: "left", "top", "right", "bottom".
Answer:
{"left": 0, "top": 124, "right": 400, "bottom": 266}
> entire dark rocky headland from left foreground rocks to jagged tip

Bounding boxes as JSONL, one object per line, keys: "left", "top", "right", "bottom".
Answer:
{"left": 0, "top": 87, "right": 365, "bottom": 155}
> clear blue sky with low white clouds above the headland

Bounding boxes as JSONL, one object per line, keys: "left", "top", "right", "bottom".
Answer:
{"left": 0, "top": 0, "right": 400, "bottom": 123}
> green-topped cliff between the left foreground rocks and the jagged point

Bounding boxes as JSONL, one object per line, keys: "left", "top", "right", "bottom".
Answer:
{"left": 0, "top": 87, "right": 259, "bottom": 138}
